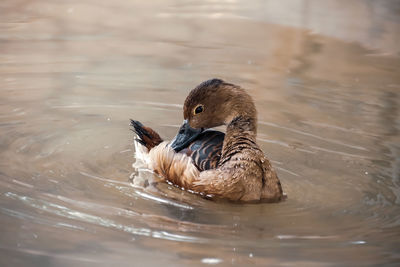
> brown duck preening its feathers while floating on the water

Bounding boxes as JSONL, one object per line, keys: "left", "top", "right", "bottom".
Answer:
{"left": 131, "top": 79, "right": 283, "bottom": 202}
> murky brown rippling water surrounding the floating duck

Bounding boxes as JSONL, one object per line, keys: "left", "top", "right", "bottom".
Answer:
{"left": 0, "top": 0, "right": 400, "bottom": 266}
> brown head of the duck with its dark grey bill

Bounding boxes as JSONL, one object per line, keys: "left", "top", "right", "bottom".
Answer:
{"left": 171, "top": 79, "right": 257, "bottom": 152}
